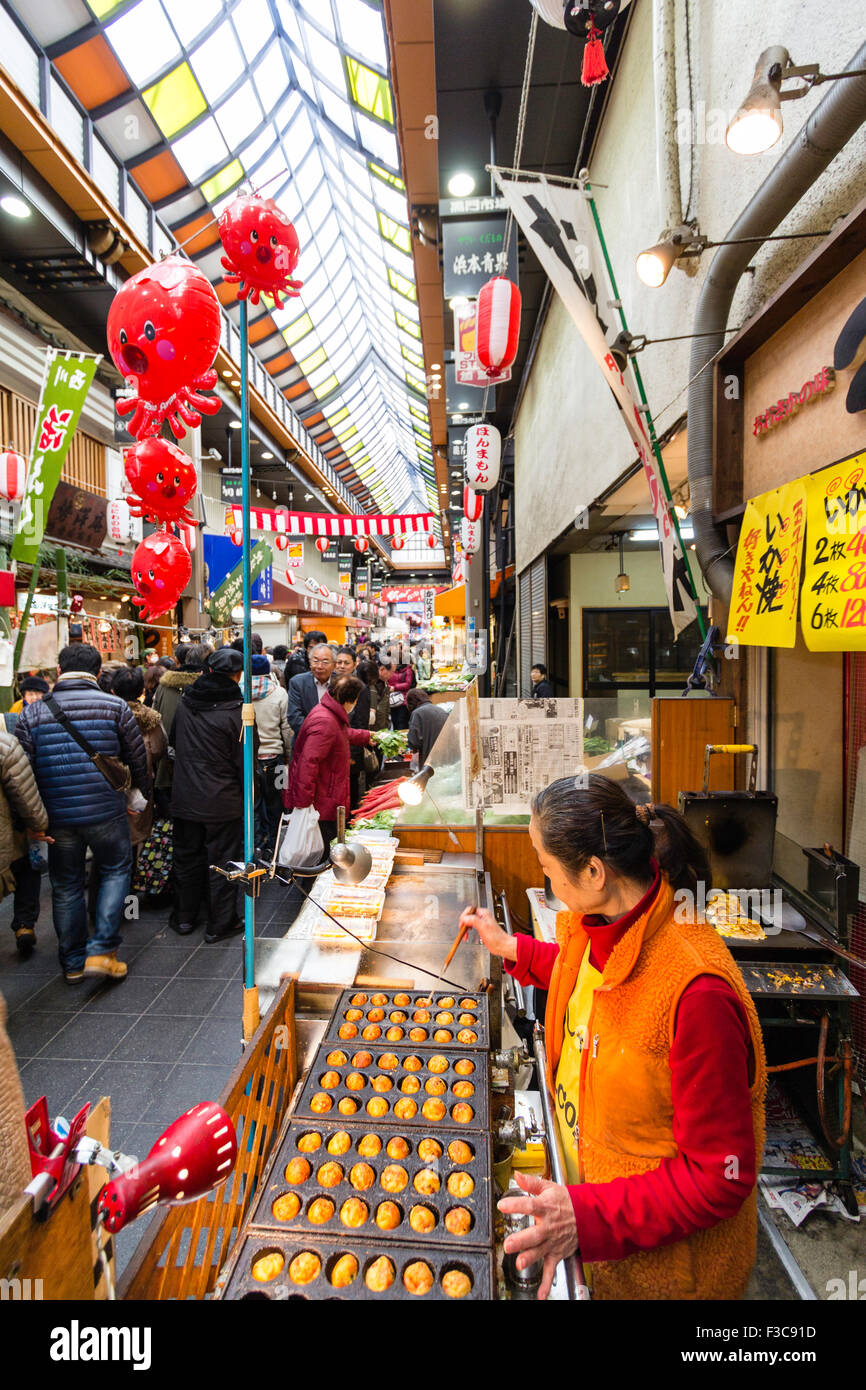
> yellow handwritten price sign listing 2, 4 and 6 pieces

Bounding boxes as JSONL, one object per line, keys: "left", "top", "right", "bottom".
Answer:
{"left": 799, "top": 453, "right": 866, "bottom": 652}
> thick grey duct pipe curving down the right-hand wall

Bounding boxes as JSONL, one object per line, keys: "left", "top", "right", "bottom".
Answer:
{"left": 688, "top": 43, "right": 866, "bottom": 602}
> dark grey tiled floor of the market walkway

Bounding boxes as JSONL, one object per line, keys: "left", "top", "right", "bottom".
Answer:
{"left": 0, "top": 874, "right": 300, "bottom": 1270}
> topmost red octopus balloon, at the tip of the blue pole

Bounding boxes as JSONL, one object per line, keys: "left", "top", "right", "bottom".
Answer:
{"left": 220, "top": 193, "right": 303, "bottom": 306}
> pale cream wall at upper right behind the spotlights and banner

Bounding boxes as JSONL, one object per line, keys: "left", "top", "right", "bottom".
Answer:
{"left": 516, "top": 0, "right": 866, "bottom": 573}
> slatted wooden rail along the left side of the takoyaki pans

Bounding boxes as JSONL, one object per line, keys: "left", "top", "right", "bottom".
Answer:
{"left": 118, "top": 980, "right": 297, "bottom": 1300}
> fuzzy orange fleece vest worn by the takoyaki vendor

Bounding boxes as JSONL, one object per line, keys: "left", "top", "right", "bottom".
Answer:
{"left": 545, "top": 877, "right": 766, "bottom": 1300}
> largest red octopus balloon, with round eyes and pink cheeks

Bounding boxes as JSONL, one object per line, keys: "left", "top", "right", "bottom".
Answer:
{"left": 107, "top": 256, "right": 220, "bottom": 439}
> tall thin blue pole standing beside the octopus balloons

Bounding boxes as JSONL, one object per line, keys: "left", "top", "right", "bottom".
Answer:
{"left": 240, "top": 299, "right": 259, "bottom": 1043}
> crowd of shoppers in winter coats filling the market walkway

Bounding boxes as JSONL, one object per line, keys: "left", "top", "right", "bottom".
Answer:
{"left": 0, "top": 631, "right": 446, "bottom": 986}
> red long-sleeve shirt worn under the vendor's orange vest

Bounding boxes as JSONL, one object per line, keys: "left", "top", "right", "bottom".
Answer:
{"left": 506, "top": 881, "right": 756, "bottom": 1264}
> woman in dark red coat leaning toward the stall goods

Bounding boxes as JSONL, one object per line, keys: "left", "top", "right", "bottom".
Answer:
{"left": 282, "top": 676, "right": 370, "bottom": 853}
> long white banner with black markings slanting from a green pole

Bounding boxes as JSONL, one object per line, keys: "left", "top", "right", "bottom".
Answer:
{"left": 493, "top": 170, "right": 698, "bottom": 634}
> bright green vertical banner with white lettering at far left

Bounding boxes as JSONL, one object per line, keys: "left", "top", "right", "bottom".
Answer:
{"left": 13, "top": 348, "right": 101, "bottom": 564}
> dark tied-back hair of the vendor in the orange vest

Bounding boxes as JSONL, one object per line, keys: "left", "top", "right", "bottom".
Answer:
{"left": 532, "top": 773, "right": 710, "bottom": 892}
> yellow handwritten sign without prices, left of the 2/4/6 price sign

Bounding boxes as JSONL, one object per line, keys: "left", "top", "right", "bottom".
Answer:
{"left": 727, "top": 478, "right": 806, "bottom": 646}
